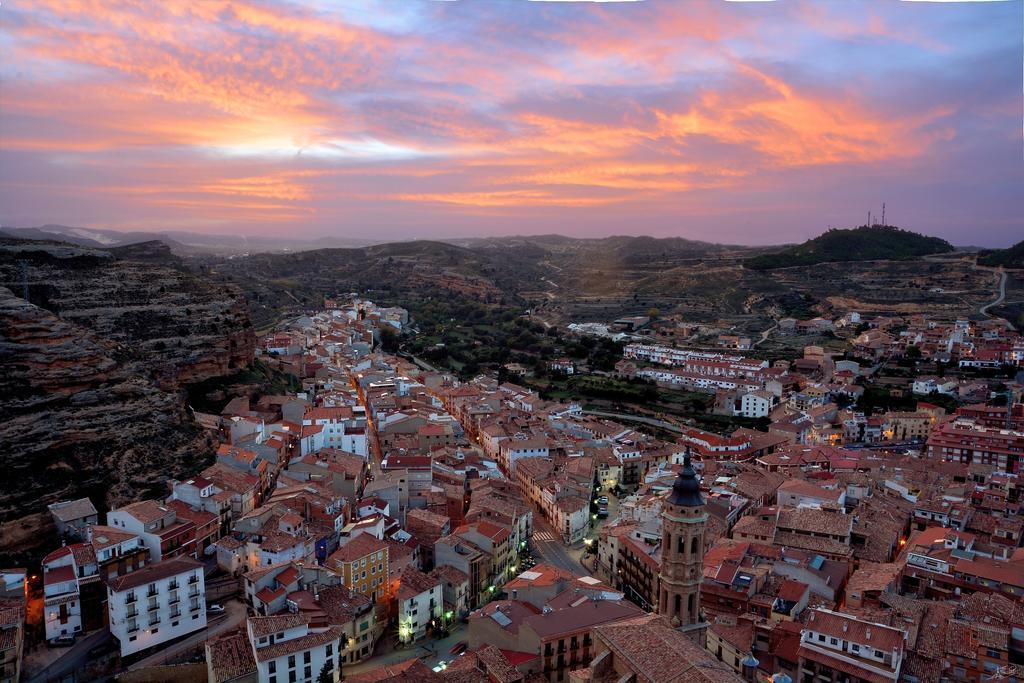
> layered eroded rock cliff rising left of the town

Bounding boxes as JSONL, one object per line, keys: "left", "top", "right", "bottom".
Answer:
{"left": 0, "top": 243, "right": 255, "bottom": 540}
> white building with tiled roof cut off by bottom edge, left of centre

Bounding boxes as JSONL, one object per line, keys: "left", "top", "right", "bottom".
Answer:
{"left": 246, "top": 613, "right": 347, "bottom": 683}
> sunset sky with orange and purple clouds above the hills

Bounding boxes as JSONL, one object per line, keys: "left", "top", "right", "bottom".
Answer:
{"left": 0, "top": 0, "right": 1024, "bottom": 246}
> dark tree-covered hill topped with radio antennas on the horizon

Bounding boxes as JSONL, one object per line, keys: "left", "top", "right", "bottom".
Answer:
{"left": 743, "top": 225, "right": 953, "bottom": 270}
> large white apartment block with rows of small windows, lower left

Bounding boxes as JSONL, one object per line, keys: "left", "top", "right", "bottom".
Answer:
{"left": 106, "top": 557, "right": 206, "bottom": 656}
